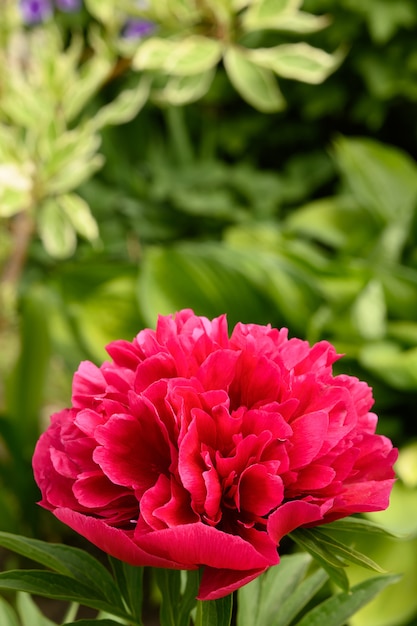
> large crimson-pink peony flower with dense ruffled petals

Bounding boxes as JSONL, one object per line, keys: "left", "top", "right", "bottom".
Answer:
{"left": 33, "top": 310, "right": 397, "bottom": 599}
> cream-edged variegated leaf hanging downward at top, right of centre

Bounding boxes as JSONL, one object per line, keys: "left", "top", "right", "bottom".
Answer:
{"left": 224, "top": 46, "right": 285, "bottom": 113}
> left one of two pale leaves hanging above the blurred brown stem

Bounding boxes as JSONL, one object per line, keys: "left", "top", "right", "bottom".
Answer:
{"left": 37, "top": 198, "right": 77, "bottom": 259}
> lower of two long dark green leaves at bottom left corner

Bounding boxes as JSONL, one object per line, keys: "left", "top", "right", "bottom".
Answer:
{"left": 0, "top": 570, "right": 129, "bottom": 618}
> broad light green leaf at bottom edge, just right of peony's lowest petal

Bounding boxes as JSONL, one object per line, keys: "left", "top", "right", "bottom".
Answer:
{"left": 237, "top": 552, "right": 312, "bottom": 626}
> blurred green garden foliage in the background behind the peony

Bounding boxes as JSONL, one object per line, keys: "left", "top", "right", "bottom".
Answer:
{"left": 0, "top": 0, "right": 417, "bottom": 626}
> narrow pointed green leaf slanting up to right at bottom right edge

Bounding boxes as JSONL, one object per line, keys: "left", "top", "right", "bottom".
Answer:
{"left": 296, "top": 576, "right": 400, "bottom": 626}
